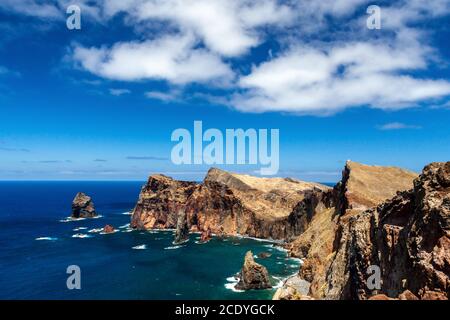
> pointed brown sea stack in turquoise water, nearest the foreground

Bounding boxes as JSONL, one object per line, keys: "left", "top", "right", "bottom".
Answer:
{"left": 236, "top": 251, "right": 272, "bottom": 290}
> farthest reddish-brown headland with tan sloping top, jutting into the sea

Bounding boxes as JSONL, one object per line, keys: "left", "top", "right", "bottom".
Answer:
{"left": 131, "top": 169, "right": 330, "bottom": 239}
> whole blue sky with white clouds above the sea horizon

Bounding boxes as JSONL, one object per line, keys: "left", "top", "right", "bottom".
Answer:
{"left": 0, "top": 0, "right": 450, "bottom": 182}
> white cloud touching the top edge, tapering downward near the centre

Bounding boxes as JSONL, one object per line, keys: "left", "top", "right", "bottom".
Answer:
{"left": 105, "top": 0, "right": 295, "bottom": 56}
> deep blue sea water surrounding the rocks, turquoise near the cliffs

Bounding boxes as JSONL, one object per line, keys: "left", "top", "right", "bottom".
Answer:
{"left": 0, "top": 182, "right": 299, "bottom": 299}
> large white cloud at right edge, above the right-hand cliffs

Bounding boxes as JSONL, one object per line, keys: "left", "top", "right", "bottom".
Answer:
{"left": 231, "top": 39, "right": 450, "bottom": 114}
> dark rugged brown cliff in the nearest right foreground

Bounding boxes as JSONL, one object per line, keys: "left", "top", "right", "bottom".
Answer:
{"left": 323, "top": 162, "right": 450, "bottom": 299}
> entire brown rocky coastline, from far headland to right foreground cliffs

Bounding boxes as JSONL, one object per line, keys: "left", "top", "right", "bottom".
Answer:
{"left": 130, "top": 161, "right": 450, "bottom": 300}
